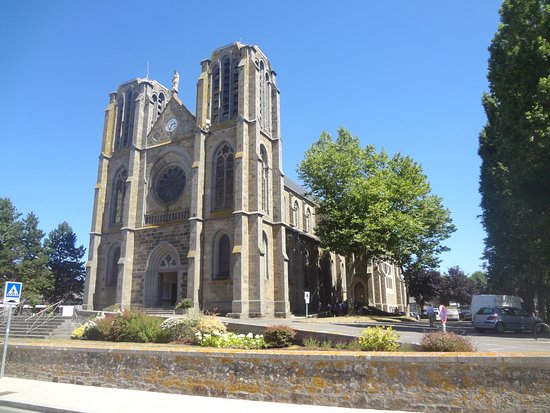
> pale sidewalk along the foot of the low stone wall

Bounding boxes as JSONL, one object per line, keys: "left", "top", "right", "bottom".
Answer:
{"left": 0, "top": 377, "right": 416, "bottom": 413}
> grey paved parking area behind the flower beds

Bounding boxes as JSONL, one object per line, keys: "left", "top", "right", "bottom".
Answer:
{"left": 225, "top": 317, "right": 550, "bottom": 352}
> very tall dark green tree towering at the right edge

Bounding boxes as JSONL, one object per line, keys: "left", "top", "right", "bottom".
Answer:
{"left": 479, "top": 0, "right": 550, "bottom": 319}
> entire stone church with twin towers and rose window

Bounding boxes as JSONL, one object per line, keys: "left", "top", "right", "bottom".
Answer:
{"left": 84, "top": 43, "right": 407, "bottom": 318}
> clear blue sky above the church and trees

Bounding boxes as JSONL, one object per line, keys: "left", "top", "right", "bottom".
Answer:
{"left": 0, "top": 0, "right": 501, "bottom": 273}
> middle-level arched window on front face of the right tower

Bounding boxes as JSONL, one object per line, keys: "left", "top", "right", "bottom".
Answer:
{"left": 213, "top": 144, "right": 235, "bottom": 209}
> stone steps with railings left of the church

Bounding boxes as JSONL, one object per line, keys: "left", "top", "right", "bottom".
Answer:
{"left": 0, "top": 315, "right": 77, "bottom": 339}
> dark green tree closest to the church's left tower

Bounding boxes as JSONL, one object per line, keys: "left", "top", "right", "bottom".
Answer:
{"left": 44, "top": 222, "right": 86, "bottom": 301}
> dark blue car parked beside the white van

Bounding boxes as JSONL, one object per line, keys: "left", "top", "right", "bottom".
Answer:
{"left": 472, "top": 306, "right": 542, "bottom": 333}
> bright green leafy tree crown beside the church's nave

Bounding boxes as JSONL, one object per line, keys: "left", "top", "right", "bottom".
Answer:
{"left": 298, "top": 128, "right": 455, "bottom": 300}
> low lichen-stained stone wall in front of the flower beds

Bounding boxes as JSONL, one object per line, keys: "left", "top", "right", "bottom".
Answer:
{"left": 6, "top": 342, "right": 550, "bottom": 413}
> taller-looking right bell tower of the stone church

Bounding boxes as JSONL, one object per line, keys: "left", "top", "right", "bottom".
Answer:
{"left": 188, "top": 43, "right": 290, "bottom": 317}
